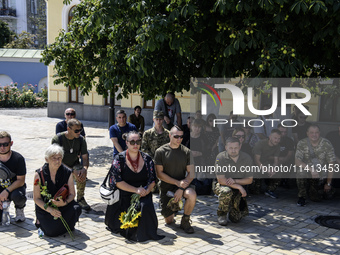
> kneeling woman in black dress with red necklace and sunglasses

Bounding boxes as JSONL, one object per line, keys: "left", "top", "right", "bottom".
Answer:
{"left": 105, "top": 131, "right": 164, "bottom": 242}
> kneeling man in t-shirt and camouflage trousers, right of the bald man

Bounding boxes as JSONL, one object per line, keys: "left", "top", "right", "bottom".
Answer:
{"left": 213, "top": 137, "right": 253, "bottom": 226}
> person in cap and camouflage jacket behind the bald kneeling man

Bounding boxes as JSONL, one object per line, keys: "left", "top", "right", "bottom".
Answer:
{"left": 141, "top": 111, "right": 170, "bottom": 158}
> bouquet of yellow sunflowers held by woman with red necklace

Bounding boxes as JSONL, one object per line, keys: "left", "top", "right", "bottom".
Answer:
{"left": 119, "top": 194, "right": 142, "bottom": 229}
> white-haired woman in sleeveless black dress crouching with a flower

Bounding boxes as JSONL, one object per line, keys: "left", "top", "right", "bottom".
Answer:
{"left": 33, "top": 144, "right": 81, "bottom": 236}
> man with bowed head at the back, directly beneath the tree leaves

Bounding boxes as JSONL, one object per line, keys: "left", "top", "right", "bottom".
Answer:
{"left": 155, "top": 92, "right": 182, "bottom": 130}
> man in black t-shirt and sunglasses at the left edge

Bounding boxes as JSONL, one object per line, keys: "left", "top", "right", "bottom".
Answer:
{"left": 0, "top": 131, "right": 27, "bottom": 221}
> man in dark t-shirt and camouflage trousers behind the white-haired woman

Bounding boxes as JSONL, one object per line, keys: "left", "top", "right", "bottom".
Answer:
{"left": 52, "top": 119, "right": 91, "bottom": 210}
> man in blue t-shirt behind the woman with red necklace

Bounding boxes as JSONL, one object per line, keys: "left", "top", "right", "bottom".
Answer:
{"left": 109, "top": 110, "right": 137, "bottom": 157}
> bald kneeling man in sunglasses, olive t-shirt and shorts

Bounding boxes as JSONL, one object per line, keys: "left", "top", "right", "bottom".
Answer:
{"left": 155, "top": 126, "right": 196, "bottom": 234}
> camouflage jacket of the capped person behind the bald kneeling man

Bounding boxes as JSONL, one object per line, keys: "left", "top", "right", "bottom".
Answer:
{"left": 141, "top": 127, "right": 170, "bottom": 158}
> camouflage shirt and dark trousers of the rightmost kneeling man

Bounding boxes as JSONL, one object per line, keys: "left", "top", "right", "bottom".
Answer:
{"left": 295, "top": 137, "right": 336, "bottom": 201}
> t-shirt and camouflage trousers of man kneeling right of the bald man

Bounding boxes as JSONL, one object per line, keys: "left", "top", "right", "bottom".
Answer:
{"left": 213, "top": 151, "right": 253, "bottom": 222}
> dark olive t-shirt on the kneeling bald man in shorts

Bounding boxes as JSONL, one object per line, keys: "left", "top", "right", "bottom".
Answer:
{"left": 154, "top": 143, "right": 193, "bottom": 190}
